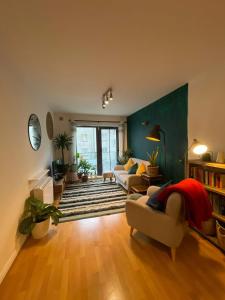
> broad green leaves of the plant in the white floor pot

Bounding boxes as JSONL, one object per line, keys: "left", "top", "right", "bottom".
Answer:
{"left": 18, "top": 197, "right": 62, "bottom": 234}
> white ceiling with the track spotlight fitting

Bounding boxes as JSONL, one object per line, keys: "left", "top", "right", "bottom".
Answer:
{"left": 0, "top": 0, "right": 225, "bottom": 115}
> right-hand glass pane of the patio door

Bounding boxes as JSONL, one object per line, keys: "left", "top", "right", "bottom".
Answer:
{"left": 101, "top": 128, "right": 118, "bottom": 173}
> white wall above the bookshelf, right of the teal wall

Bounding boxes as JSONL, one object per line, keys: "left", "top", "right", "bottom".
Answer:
{"left": 188, "top": 64, "right": 225, "bottom": 158}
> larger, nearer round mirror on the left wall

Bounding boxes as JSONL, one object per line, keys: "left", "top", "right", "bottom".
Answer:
{"left": 28, "top": 114, "right": 41, "bottom": 151}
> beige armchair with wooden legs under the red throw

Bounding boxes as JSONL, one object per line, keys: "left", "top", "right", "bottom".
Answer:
{"left": 126, "top": 186, "right": 186, "bottom": 261}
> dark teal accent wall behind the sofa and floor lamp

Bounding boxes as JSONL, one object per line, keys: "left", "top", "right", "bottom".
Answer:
{"left": 127, "top": 84, "right": 188, "bottom": 182}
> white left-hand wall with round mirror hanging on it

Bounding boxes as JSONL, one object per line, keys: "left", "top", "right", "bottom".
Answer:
{"left": 0, "top": 66, "right": 52, "bottom": 282}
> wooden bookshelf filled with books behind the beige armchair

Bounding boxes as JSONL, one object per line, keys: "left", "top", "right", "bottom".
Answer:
{"left": 188, "top": 160, "right": 225, "bottom": 253}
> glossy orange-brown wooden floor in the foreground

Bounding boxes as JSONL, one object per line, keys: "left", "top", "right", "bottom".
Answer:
{"left": 0, "top": 214, "right": 225, "bottom": 300}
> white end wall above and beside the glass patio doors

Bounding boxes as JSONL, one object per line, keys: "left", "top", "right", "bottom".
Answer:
{"left": 54, "top": 113, "right": 127, "bottom": 161}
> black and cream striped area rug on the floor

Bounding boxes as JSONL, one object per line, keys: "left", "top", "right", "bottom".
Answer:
{"left": 58, "top": 179, "right": 127, "bottom": 223}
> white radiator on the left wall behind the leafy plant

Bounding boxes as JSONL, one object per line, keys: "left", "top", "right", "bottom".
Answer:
{"left": 32, "top": 177, "right": 54, "bottom": 204}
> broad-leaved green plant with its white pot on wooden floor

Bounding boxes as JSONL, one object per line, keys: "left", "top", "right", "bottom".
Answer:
{"left": 18, "top": 197, "right": 62, "bottom": 239}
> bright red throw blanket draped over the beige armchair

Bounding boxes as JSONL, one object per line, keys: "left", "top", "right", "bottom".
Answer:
{"left": 157, "top": 178, "right": 212, "bottom": 229}
